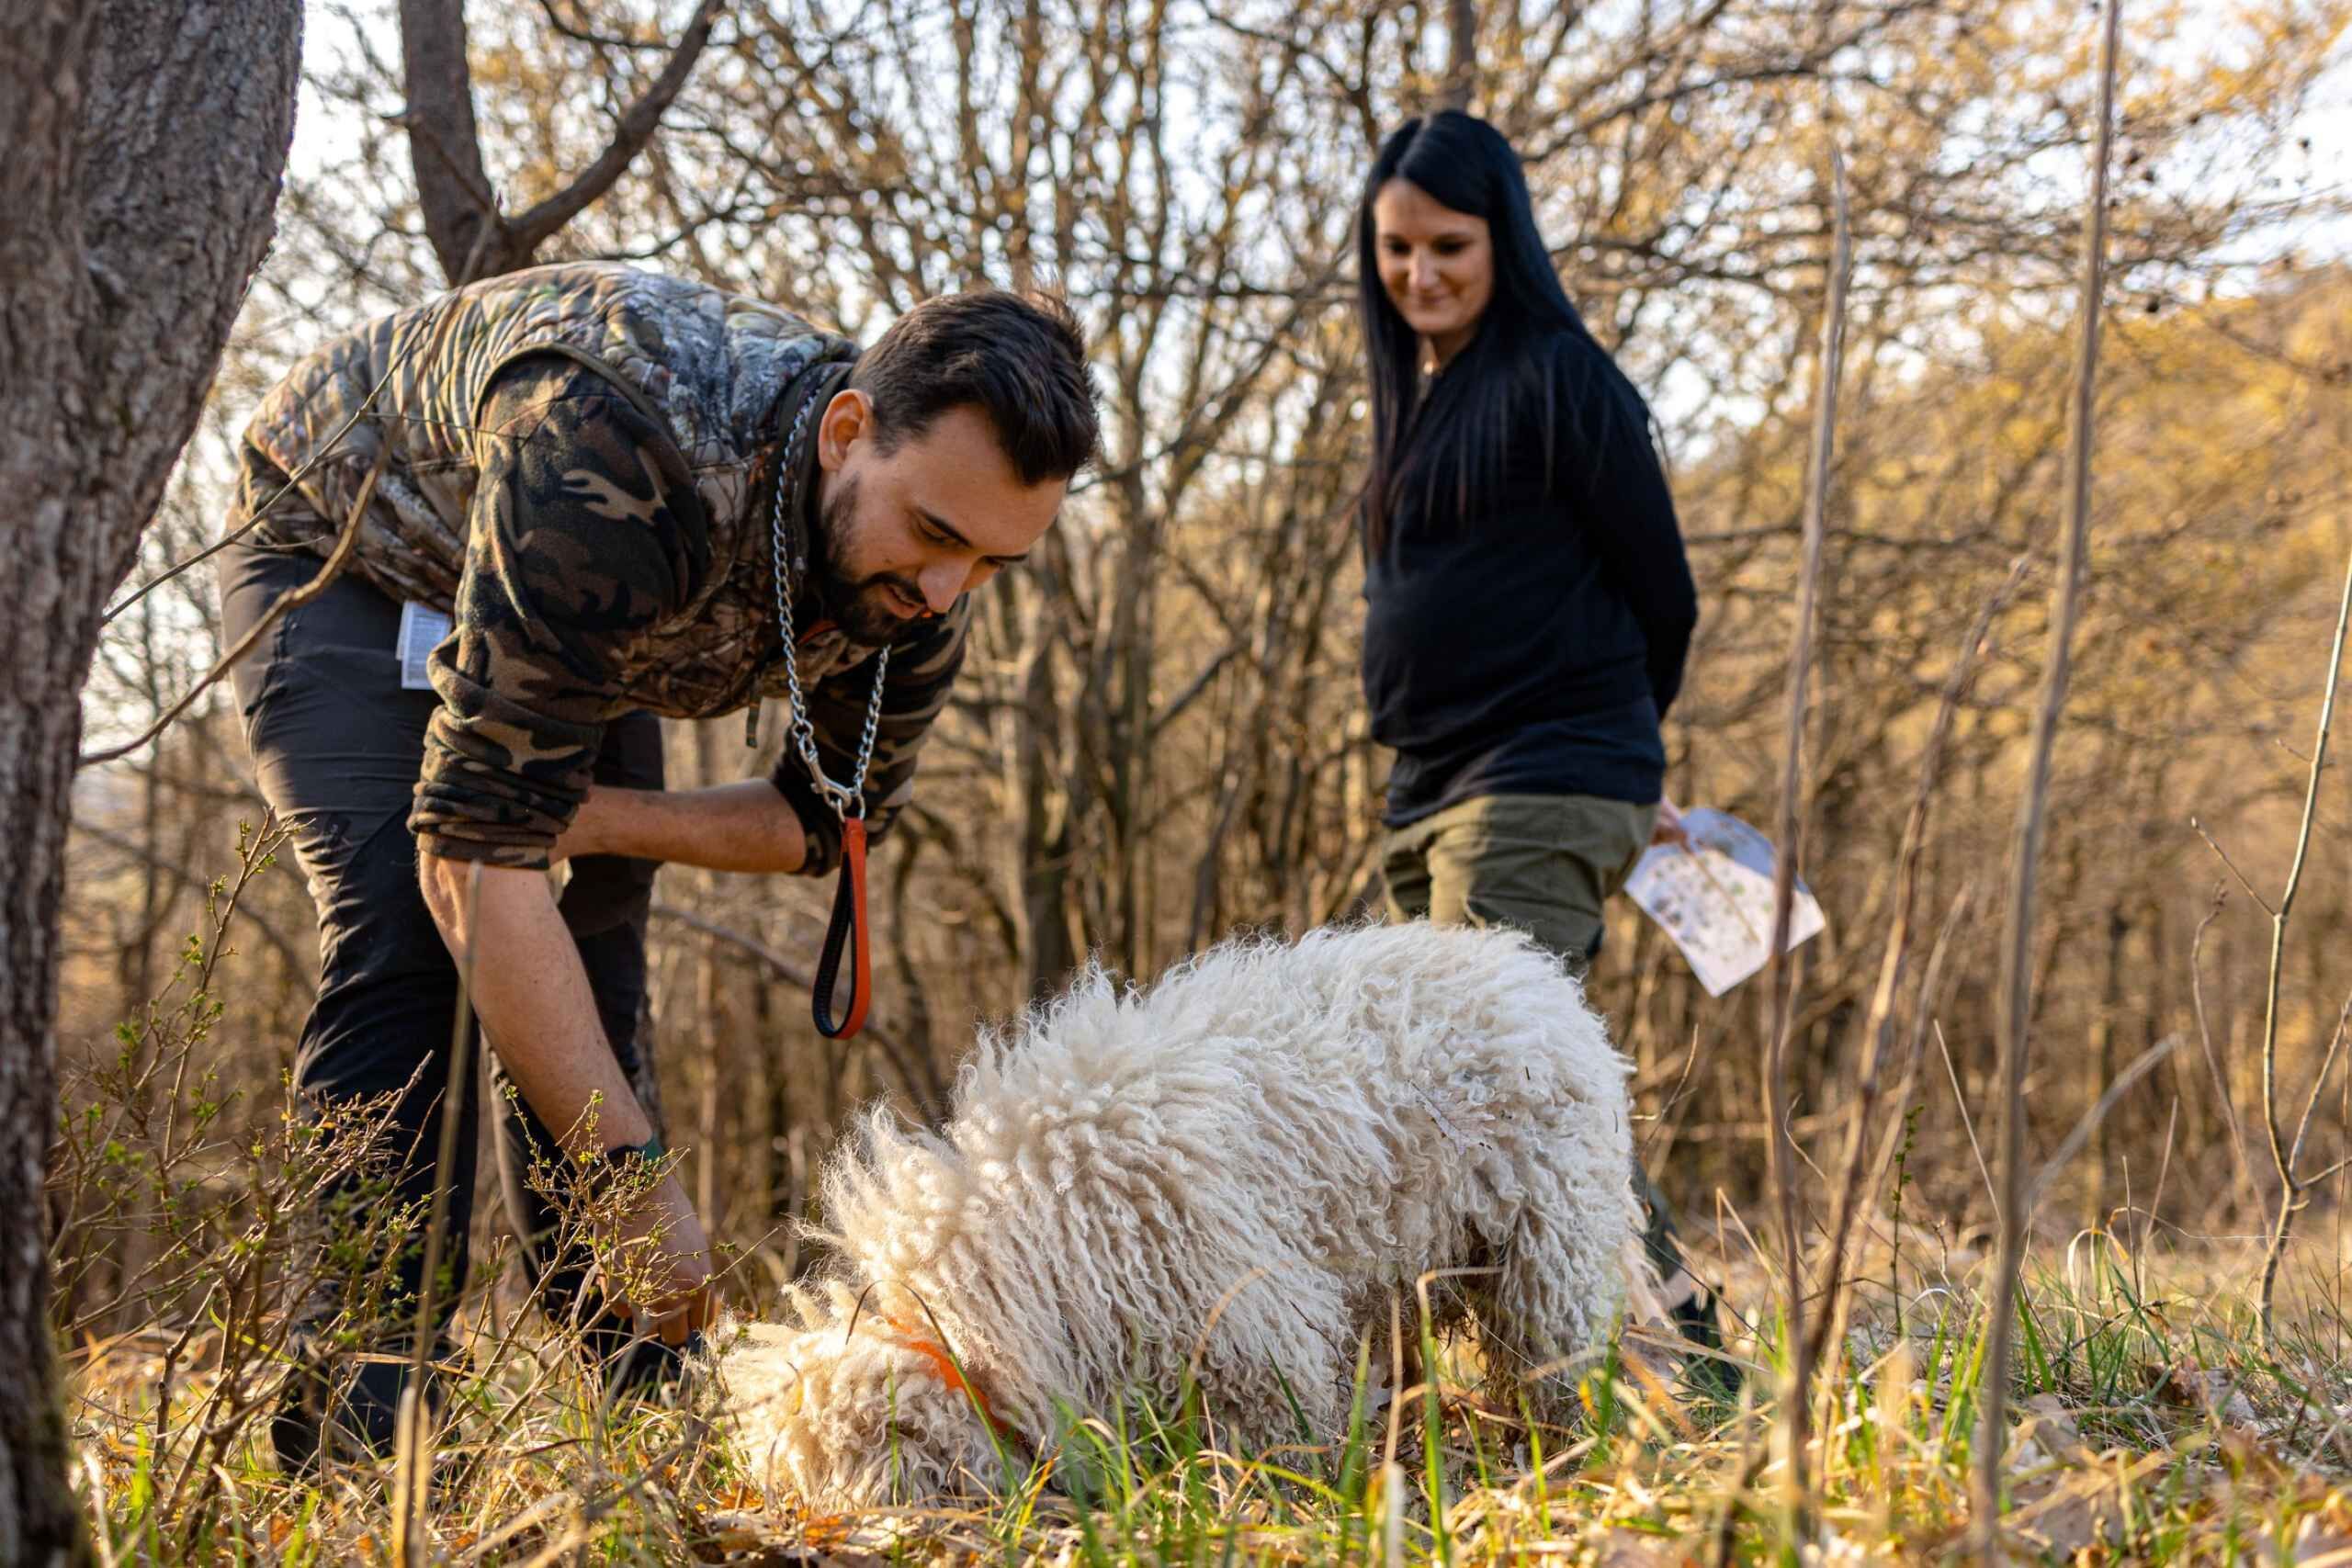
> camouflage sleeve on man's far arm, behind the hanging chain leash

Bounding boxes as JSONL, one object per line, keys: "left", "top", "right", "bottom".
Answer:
{"left": 772, "top": 594, "right": 971, "bottom": 877}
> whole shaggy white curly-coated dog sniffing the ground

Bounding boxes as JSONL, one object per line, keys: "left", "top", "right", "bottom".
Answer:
{"left": 722, "top": 924, "right": 1639, "bottom": 1506}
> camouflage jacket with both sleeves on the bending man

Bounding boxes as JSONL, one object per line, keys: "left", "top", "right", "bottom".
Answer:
{"left": 238, "top": 264, "right": 969, "bottom": 874}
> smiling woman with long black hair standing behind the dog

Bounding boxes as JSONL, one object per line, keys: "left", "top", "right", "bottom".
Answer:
{"left": 1357, "top": 110, "right": 1713, "bottom": 1382}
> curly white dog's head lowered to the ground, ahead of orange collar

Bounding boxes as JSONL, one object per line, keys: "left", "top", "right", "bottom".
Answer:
{"left": 719, "top": 1309, "right": 1018, "bottom": 1512}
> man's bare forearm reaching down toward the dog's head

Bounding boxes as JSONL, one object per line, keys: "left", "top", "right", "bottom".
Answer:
{"left": 416, "top": 853, "right": 654, "bottom": 1152}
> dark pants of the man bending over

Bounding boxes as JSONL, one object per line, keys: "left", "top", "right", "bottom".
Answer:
{"left": 219, "top": 546, "right": 668, "bottom": 1464}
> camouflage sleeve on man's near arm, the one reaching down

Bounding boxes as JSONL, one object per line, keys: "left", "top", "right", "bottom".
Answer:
{"left": 409, "top": 355, "right": 708, "bottom": 867}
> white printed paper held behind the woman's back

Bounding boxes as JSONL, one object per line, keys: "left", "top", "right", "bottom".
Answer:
{"left": 1625, "top": 807, "right": 1823, "bottom": 997}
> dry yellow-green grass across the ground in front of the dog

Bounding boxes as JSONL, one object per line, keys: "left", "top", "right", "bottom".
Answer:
{"left": 71, "top": 1235, "right": 2352, "bottom": 1563}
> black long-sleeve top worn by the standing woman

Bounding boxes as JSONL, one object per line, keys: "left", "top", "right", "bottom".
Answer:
{"left": 1364, "top": 333, "right": 1698, "bottom": 828}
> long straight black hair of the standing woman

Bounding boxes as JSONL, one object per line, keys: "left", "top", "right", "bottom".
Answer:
{"left": 1355, "top": 108, "right": 1649, "bottom": 550}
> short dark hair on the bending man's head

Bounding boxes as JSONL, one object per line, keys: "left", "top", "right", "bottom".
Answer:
{"left": 849, "top": 289, "right": 1101, "bottom": 484}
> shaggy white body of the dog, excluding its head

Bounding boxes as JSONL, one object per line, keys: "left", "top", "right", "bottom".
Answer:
{"left": 799, "top": 924, "right": 1634, "bottom": 1457}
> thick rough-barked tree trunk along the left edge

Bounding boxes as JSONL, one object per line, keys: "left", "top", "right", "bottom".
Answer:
{"left": 0, "top": 0, "right": 301, "bottom": 1563}
